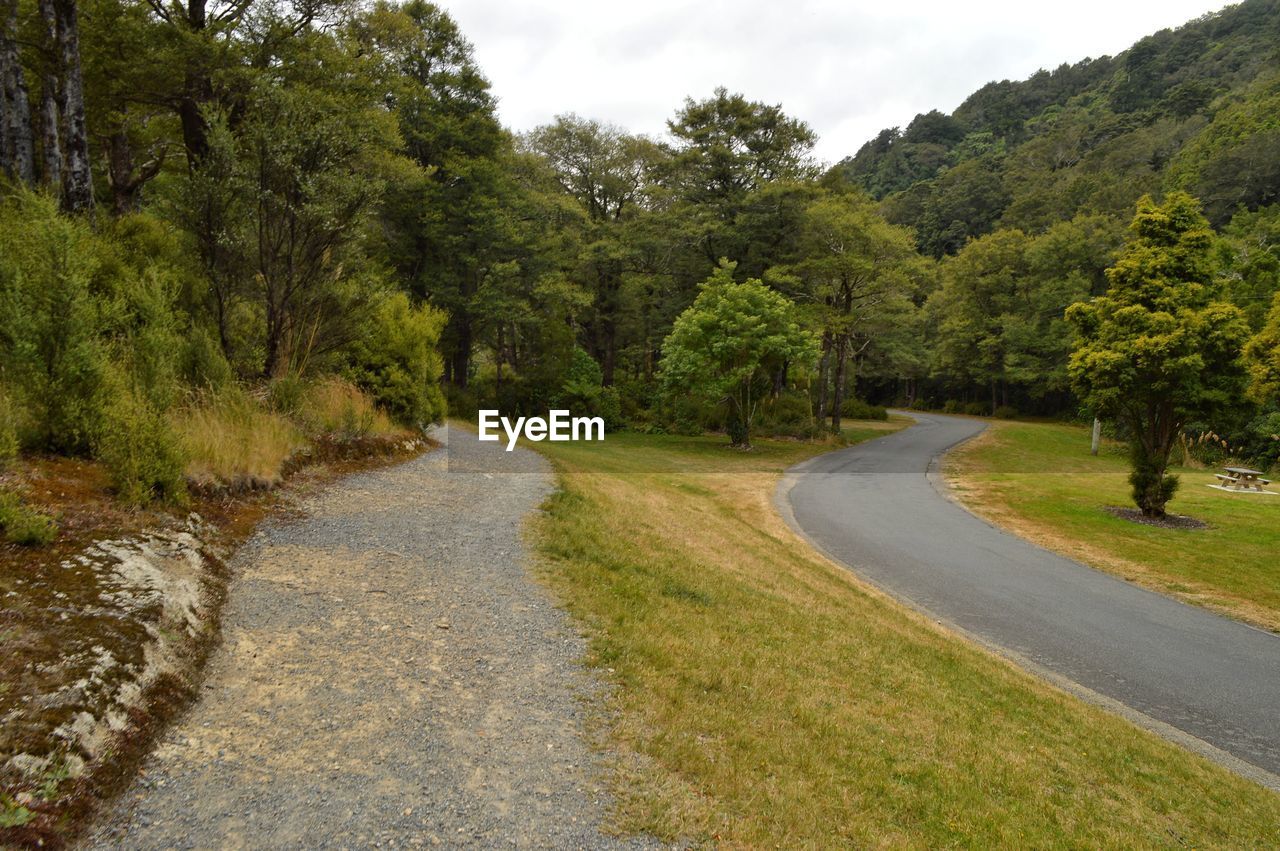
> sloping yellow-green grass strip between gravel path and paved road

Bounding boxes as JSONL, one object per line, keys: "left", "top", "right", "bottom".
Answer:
{"left": 532, "top": 426, "right": 1280, "bottom": 848}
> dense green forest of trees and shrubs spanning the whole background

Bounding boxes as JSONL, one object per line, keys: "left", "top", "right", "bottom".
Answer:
{"left": 0, "top": 0, "right": 1280, "bottom": 511}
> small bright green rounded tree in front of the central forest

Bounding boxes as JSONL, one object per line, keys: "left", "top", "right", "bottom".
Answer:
{"left": 662, "top": 260, "right": 817, "bottom": 449}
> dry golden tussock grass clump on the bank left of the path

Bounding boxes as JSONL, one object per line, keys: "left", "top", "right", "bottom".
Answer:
{"left": 170, "top": 385, "right": 306, "bottom": 486}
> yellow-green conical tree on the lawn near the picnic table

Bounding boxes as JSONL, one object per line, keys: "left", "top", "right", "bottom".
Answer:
{"left": 1066, "top": 192, "right": 1248, "bottom": 517}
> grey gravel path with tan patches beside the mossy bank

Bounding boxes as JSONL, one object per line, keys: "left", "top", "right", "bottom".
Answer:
{"left": 87, "top": 430, "right": 641, "bottom": 848}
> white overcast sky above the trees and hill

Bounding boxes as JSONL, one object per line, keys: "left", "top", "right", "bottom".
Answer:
{"left": 442, "top": 0, "right": 1225, "bottom": 163}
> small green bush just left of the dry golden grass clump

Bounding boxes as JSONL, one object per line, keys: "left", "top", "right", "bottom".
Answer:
{"left": 95, "top": 390, "right": 187, "bottom": 505}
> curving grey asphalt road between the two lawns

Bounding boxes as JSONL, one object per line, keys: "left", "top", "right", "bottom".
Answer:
{"left": 780, "top": 415, "right": 1280, "bottom": 784}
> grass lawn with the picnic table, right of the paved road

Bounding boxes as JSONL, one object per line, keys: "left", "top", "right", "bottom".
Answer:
{"left": 947, "top": 422, "right": 1280, "bottom": 631}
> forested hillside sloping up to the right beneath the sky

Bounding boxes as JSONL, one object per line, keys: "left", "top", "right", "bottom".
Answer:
{"left": 832, "top": 0, "right": 1280, "bottom": 257}
